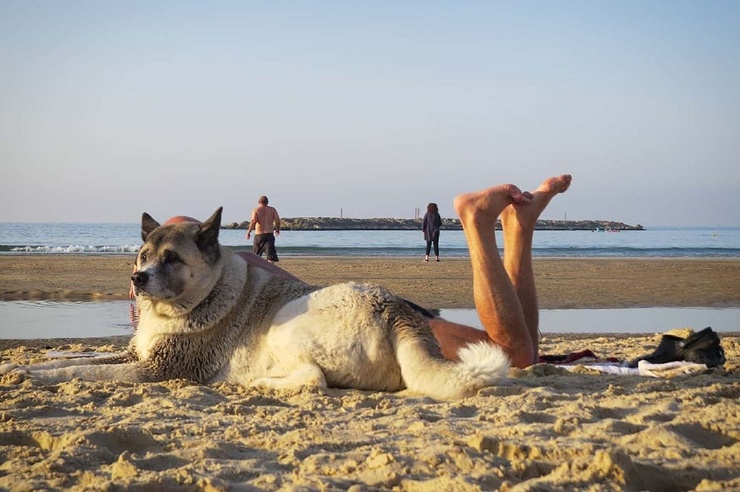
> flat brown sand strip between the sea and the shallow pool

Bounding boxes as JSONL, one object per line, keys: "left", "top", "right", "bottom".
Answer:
{"left": 0, "top": 255, "right": 740, "bottom": 309}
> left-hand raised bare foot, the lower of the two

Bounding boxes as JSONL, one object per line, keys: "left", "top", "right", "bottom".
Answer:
{"left": 452, "top": 184, "right": 533, "bottom": 226}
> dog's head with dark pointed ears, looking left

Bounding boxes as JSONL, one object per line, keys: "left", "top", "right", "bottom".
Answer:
{"left": 131, "top": 207, "right": 223, "bottom": 305}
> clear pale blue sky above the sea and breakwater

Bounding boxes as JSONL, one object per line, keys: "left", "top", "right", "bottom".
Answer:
{"left": 0, "top": 0, "right": 740, "bottom": 226}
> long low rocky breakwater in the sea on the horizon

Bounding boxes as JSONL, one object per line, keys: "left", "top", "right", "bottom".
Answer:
{"left": 223, "top": 217, "right": 644, "bottom": 231}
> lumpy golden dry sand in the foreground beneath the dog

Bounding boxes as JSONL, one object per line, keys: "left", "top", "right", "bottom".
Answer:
{"left": 0, "top": 335, "right": 740, "bottom": 491}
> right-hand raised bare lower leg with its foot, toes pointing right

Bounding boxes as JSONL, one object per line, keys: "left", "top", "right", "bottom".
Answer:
{"left": 500, "top": 174, "right": 572, "bottom": 357}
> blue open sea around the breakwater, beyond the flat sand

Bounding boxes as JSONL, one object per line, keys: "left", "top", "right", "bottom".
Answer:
{"left": 0, "top": 223, "right": 740, "bottom": 258}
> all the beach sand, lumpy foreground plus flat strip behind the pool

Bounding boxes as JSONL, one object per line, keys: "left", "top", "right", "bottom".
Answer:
{"left": 0, "top": 255, "right": 740, "bottom": 491}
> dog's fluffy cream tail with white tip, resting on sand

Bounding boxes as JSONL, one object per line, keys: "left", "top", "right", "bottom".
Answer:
{"left": 396, "top": 339, "right": 510, "bottom": 400}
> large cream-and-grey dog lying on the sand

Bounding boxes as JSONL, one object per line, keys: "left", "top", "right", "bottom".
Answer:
{"left": 0, "top": 208, "right": 509, "bottom": 400}
